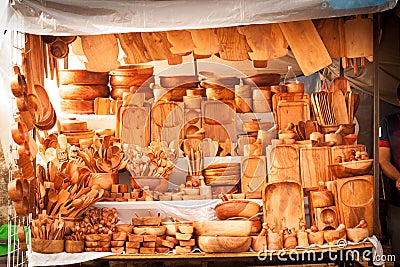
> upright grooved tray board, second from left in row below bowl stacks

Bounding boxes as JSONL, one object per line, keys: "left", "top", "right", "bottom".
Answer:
{"left": 151, "top": 101, "right": 184, "bottom": 147}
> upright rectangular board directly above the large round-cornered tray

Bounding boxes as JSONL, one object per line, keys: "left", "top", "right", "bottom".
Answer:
{"left": 268, "top": 145, "right": 301, "bottom": 183}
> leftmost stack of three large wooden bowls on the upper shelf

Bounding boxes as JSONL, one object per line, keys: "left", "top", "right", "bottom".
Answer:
{"left": 59, "top": 70, "right": 110, "bottom": 114}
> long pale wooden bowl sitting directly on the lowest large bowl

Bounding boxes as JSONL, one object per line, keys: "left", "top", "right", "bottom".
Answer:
{"left": 193, "top": 221, "right": 251, "bottom": 236}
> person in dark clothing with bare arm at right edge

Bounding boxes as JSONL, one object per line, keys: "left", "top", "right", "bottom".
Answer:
{"left": 379, "top": 84, "right": 400, "bottom": 267}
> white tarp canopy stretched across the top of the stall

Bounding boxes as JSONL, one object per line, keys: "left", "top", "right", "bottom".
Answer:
{"left": 0, "top": 0, "right": 397, "bottom": 35}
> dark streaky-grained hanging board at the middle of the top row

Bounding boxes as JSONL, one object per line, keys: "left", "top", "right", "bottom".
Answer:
{"left": 215, "top": 27, "right": 251, "bottom": 61}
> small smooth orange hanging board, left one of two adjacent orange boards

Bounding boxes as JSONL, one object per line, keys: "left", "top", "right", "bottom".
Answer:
{"left": 167, "top": 30, "right": 195, "bottom": 54}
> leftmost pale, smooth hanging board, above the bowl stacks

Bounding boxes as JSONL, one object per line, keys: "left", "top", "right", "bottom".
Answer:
{"left": 81, "top": 34, "right": 119, "bottom": 72}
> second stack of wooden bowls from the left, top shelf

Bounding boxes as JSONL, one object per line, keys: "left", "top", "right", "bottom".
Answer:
{"left": 110, "top": 64, "right": 154, "bottom": 100}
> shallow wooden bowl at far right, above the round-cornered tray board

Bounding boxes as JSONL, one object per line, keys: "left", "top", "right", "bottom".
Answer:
{"left": 328, "top": 159, "right": 374, "bottom": 178}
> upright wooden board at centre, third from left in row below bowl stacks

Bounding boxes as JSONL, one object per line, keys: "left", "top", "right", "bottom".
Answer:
{"left": 201, "top": 100, "right": 237, "bottom": 143}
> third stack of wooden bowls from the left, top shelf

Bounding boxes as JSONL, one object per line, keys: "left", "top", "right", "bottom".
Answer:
{"left": 160, "top": 75, "right": 198, "bottom": 102}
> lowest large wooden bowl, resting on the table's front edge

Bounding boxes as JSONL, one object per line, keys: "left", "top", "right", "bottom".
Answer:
{"left": 197, "top": 236, "right": 251, "bottom": 253}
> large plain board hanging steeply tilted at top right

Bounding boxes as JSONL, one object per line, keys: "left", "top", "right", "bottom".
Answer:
{"left": 279, "top": 20, "right": 332, "bottom": 76}
